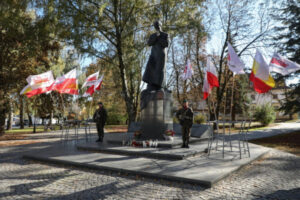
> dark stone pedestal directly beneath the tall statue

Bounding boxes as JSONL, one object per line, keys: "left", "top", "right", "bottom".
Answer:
{"left": 141, "top": 90, "right": 173, "bottom": 140}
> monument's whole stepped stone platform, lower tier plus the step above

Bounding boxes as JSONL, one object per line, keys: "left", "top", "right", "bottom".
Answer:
{"left": 24, "top": 134, "right": 269, "bottom": 187}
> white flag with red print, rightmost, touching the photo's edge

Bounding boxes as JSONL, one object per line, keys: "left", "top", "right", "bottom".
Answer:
{"left": 269, "top": 53, "right": 300, "bottom": 76}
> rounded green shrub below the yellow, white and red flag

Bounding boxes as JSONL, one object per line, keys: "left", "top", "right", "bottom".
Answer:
{"left": 254, "top": 104, "right": 276, "bottom": 126}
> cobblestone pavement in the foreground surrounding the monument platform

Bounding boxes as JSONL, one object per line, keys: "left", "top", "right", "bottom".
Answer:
{"left": 0, "top": 139, "right": 300, "bottom": 200}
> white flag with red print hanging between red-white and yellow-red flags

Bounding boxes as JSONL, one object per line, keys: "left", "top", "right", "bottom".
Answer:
{"left": 227, "top": 42, "right": 245, "bottom": 75}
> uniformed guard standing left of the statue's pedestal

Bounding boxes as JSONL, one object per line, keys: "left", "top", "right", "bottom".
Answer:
{"left": 93, "top": 102, "right": 107, "bottom": 142}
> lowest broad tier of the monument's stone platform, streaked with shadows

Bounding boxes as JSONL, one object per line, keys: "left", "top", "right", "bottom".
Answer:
{"left": 24, "top": 140, "right": 269, "bottom": 187}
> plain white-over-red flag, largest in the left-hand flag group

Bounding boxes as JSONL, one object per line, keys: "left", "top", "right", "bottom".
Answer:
{"left": 51, "top": 68, "right": 78, "bottom": 95}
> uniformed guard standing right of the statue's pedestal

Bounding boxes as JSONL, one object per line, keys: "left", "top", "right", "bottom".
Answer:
{"left": 176, "top": 100, "right": 194, "bottom": 148}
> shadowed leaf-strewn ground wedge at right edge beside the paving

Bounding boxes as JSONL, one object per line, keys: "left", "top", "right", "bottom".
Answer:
{"left": 249, "top": 131, "right": 300, "bottom": 156}
